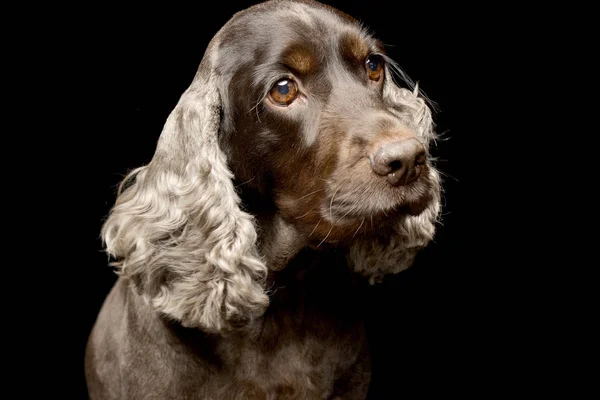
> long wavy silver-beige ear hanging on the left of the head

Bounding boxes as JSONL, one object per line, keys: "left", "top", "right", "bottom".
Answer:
{"left": 102, "top": 45, "right": 269, "bottom": 332}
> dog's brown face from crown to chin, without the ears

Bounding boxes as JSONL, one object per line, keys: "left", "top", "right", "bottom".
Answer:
{"left": 214, "top": 0, "right": 436, "bottom": 243}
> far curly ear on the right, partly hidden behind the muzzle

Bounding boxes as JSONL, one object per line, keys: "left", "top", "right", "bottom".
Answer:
{"left": 347, "top": 71, "right": 441, "bottom": 283}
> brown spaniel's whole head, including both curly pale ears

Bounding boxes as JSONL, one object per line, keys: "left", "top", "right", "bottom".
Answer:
{"left": 103, "top": 0, "right": 440, "bottom": 331}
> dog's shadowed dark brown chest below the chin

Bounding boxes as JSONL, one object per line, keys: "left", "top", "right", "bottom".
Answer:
{"left": 204, "top": 286, "right": 366, "bottom": 399}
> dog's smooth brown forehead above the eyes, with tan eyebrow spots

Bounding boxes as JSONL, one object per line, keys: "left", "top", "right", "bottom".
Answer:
{"left": 215, "top": 1, "right": 383, "bottom": 72}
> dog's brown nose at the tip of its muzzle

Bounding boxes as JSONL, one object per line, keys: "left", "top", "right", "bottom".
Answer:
{"left": 370, "top": 138, "right": 426, "bottom": 186}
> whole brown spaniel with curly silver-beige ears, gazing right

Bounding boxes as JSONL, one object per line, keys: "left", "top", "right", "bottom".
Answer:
{"left": 85, "top": 0, "right": 441, "bottom": 400}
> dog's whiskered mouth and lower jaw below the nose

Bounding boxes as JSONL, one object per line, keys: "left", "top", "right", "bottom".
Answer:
{"left": 276, "top": 162, "right": 440, "bottom": 246}
